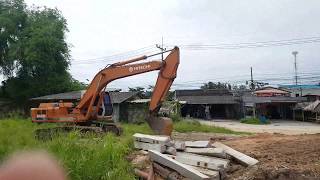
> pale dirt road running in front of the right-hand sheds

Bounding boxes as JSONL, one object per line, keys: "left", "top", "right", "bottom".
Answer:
{"left": 198, "top": 120, "right": 320, "bottom": 135}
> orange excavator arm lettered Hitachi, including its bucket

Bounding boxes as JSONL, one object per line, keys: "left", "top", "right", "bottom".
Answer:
{"left": 72, "top": 47, "right": 180, "bottom": 134}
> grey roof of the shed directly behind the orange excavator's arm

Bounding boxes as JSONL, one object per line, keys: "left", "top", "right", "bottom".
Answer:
{"left": 31, "top": 91, "right": 137, "bottom": 104}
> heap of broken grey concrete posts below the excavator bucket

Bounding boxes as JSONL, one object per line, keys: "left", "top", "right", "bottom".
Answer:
{"left": 133, "top": 133, "right": 258, "bottom": 180}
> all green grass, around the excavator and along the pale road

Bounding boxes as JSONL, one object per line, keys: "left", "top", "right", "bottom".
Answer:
{"left": 0, "top": 118, "right": 245, "bottom": 180}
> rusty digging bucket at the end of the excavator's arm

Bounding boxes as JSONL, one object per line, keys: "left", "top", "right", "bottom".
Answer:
{"left": 146, "top": 116, "right": 173, "bottom": 136}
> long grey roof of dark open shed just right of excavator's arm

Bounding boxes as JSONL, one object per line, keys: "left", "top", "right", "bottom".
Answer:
{"left": 177, "top": 96, "right": 240, "bottom": 104}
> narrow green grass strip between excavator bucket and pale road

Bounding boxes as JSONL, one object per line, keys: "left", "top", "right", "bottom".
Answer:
{"left": 174, "top": 120, "right": 247, "bottom": 134}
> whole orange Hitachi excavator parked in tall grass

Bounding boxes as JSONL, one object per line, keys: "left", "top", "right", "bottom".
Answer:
{"left": 31, "top": 47, "right": 180, "bottom": 135}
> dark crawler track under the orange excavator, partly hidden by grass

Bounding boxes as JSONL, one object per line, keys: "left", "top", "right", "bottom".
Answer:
{"left": 35, "top": 123, "right": 122, "bottom": 140}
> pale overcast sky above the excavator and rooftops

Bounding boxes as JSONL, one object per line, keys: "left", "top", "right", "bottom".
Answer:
{"left": 26, "top": 0, "right": 320, "bottom": 89}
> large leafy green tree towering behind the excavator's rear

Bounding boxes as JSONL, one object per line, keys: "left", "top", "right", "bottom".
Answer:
{"left": 0, "top": 0, "right": 83, "bottom": 104}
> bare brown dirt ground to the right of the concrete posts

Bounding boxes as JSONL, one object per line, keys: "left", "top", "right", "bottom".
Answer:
{"left": 130, "top": 132, "right": 320, "bottom": 180}
